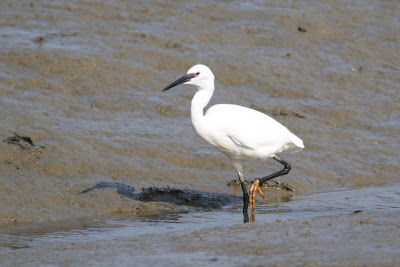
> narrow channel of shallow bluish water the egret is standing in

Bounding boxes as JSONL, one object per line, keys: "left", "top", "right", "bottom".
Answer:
{"left": 0, "top": 185, "right": 400, "bottom": 255}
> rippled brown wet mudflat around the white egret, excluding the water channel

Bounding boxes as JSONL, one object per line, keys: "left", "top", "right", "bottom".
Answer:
{"left": 0, "top": 0, "right": 400, "bottom": 265}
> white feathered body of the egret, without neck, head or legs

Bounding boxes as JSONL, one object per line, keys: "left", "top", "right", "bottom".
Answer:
{"left": 197, "top": 104, "right": 304, "bottom": 160}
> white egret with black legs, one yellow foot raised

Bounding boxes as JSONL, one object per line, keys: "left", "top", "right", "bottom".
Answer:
{"left": 163, "top": 64, "right": 304, "bottom": 215}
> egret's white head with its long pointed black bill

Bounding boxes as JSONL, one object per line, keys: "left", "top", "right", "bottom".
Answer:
{"left": 163, "top": 64, "right": 215, "bottom": 92}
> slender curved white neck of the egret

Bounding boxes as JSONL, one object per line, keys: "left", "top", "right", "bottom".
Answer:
{"left": 191, "top": 83, "right": 214, "bottom": 131}
